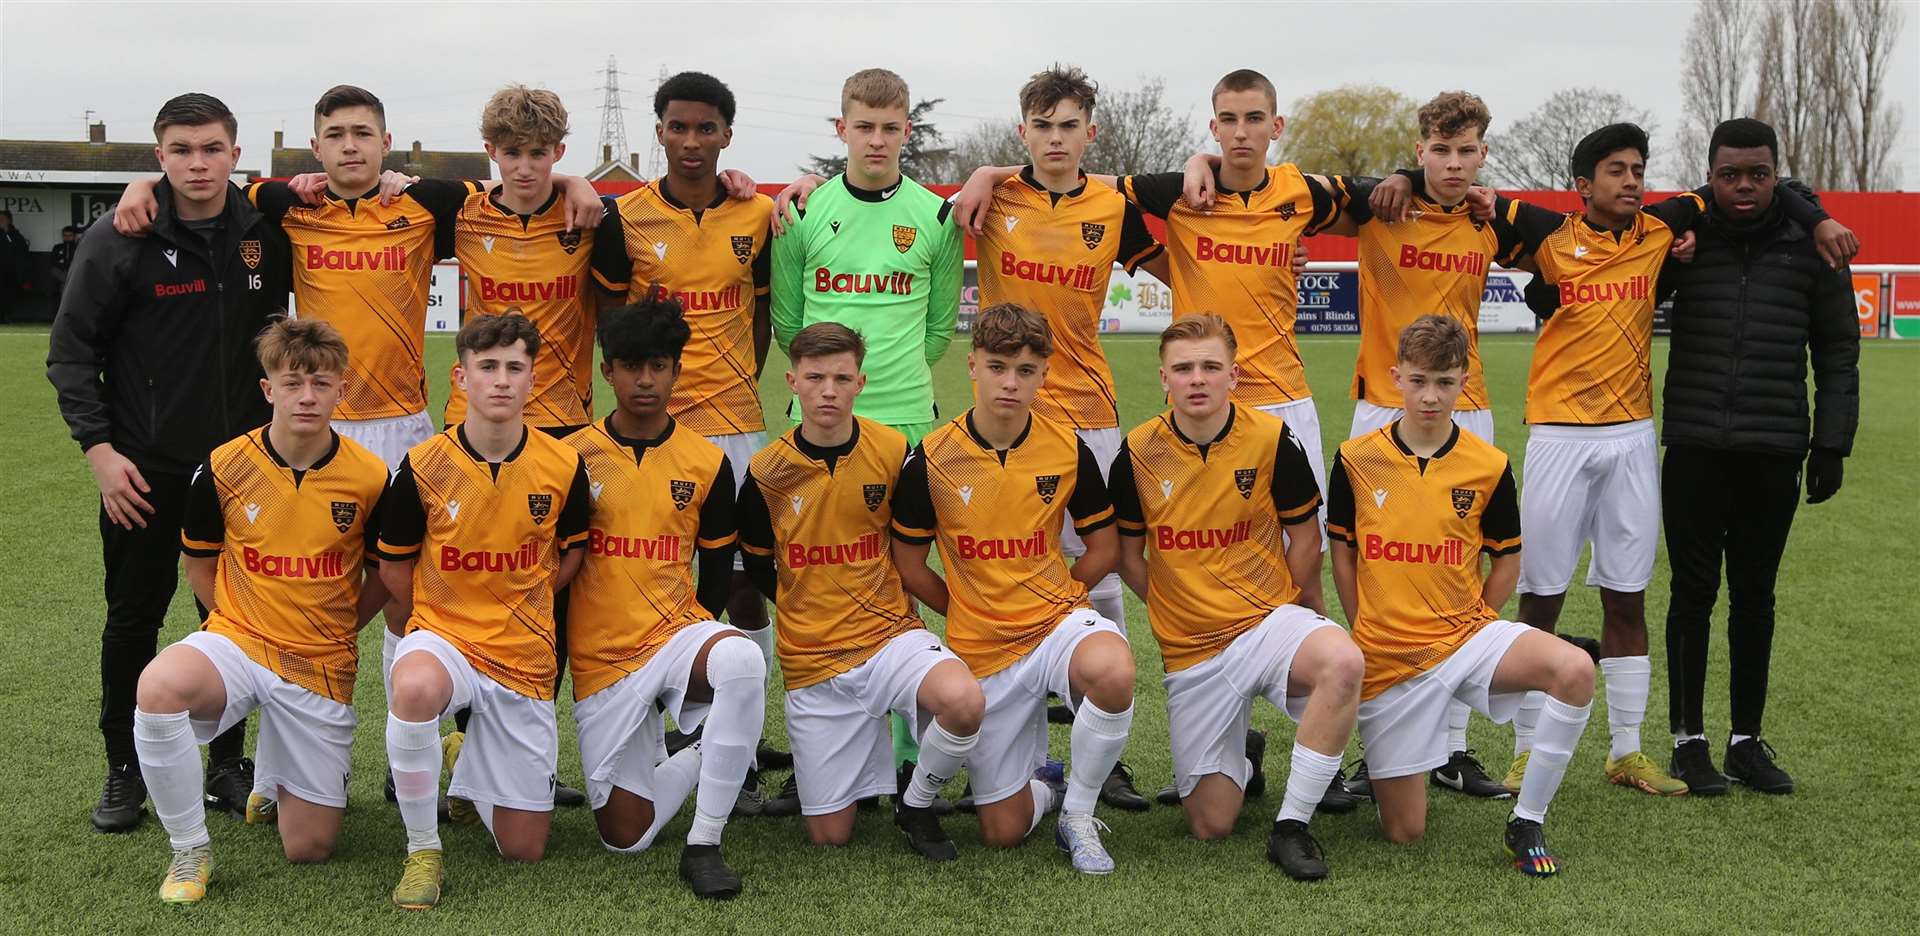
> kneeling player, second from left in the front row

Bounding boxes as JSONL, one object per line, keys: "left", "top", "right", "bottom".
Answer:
{"left": 378, "top": 313, "right": 589, "bottom": 909}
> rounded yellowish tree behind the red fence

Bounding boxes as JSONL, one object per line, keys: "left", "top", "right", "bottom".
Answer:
{"left": 1281, "top": 84, "right": 1419, "bottom": 176}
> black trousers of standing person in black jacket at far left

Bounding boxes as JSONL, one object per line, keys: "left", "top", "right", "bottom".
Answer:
{"left": 100, "top": 470, "right": 246, "bottom": 767}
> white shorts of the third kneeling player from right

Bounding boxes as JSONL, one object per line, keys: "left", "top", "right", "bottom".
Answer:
{"left": 975, "top": 608, "right": 1127, "bottom": 804}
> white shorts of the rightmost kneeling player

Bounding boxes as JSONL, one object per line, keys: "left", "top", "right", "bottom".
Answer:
{"left": 1359, "top": 621, "right": 1528, "bottom": 781}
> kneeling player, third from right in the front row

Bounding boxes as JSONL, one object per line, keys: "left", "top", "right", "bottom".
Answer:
{"left": 893, "top": 303, "right": 1133, "bottom": 875}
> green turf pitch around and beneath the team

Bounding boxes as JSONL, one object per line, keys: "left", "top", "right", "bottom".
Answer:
{"left": 0, "top": 328, "right": 1920, "bottom": 934}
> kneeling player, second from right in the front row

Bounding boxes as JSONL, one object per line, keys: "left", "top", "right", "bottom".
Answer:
{"left": 1108, "top": 315, "right": 1361, "bottom": 880}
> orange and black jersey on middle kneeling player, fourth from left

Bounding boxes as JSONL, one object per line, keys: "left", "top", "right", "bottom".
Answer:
{"left": 739, "top": 416, "right": 925, "bottom": 692}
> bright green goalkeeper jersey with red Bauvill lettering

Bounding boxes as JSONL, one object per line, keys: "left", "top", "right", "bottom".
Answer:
{"left": 772, "top": 175, "right": 964, "bottom": 426}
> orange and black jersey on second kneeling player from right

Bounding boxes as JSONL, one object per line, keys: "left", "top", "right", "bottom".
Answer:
{"left": 1108, "top": 403, "right": 1321, "bottom": 673}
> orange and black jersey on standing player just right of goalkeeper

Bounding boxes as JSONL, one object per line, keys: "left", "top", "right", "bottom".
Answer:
{"left": 975, "top": 165, "right": 1162, "bottom": 430}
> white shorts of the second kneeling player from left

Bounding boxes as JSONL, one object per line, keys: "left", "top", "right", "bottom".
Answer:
{"left": 394, "top": 631, "right": 561, "bottom": 813}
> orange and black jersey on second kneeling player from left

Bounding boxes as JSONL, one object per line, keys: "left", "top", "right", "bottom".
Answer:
{"left": 378, "top": 424, "right": 593, "bottom": 700}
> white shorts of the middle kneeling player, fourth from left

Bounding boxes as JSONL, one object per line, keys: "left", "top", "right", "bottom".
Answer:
{"left": 787, "top": 629, "right": 960, "bottom": 815}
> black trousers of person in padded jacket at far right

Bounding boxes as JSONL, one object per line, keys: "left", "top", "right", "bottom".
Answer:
{"left": 1661, "top": 447, "right": 1801, "bottom": 735}
